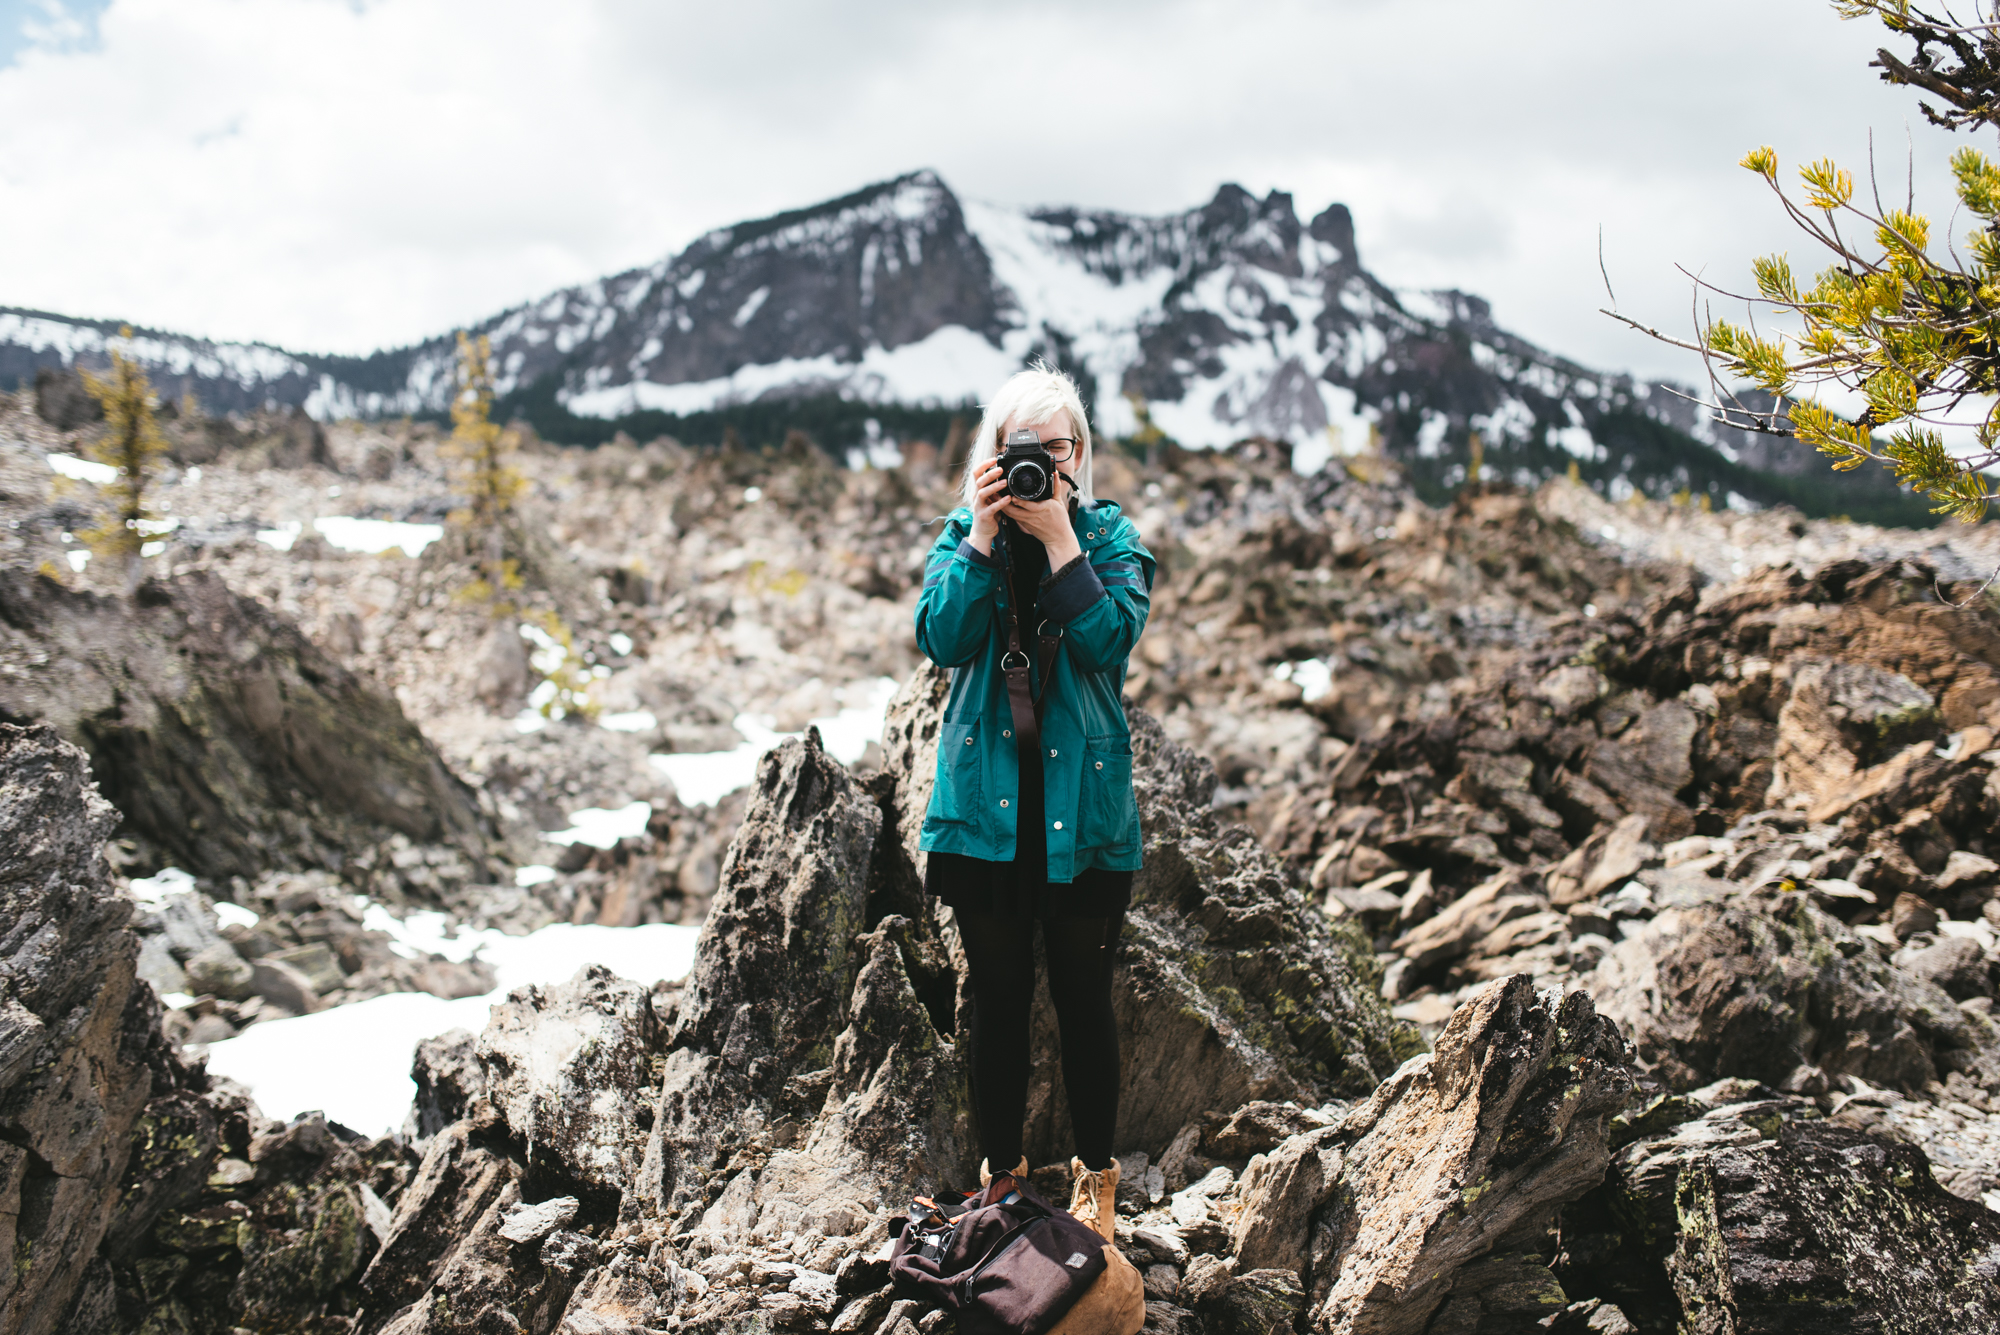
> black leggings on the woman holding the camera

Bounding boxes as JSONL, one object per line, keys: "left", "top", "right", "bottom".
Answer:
{"left": 958, "top": 911, "right": 1124, "bottom": 1171}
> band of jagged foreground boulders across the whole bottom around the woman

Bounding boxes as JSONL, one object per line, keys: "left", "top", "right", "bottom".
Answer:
{"left": 11, "top": 639, "right": 2000, "bottom": 1335}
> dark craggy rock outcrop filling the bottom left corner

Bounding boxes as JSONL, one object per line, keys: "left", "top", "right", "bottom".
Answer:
{"left": 0, "top": 723, "right": 426, "bottom": 1335}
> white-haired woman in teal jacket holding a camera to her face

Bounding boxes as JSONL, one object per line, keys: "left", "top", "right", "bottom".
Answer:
{"left": 916, "top": 366, "right": 1154, "bottom": 1241}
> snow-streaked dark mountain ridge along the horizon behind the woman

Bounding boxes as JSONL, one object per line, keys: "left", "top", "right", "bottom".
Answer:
{"left": 0, "top": 172, "right": 1922, "bottom": 522}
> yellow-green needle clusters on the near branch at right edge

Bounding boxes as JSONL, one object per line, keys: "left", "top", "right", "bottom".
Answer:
{"left": 1700, "top": 135, "right": 2000, "bottom": 524}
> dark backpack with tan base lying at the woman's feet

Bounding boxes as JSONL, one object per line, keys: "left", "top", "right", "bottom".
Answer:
{"left": 888, "top": 1173, "right": 1146, "bottom": 1335}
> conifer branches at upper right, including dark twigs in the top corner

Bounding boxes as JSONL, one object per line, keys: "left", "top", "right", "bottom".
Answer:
{"left": 1606, "top": 0, "right": 2000, "bottom": 524}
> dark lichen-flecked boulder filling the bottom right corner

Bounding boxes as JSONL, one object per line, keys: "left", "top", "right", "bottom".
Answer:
{"left": 1556, "top": 1081, "right": 2000, "bottom": 1335}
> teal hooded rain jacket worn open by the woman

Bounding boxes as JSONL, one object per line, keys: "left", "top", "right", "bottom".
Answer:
{"left": 916, "top": 502, "right": 1154, "bottom": 883}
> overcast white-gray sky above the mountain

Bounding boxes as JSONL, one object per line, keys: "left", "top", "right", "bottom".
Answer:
{"left": 0, "top": 0, "right": 1994, "bottom": 378}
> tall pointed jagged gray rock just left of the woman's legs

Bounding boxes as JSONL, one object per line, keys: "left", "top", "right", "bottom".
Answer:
{"left": 640, "top": 731, "right": 970, "bottom": 1245}
